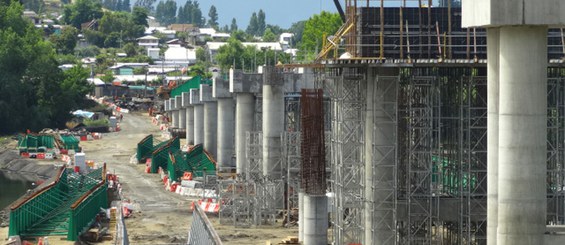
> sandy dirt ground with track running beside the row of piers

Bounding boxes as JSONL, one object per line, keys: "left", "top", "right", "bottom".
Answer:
{"left": 0, "top": 113, "right": 298, "bottom": 245}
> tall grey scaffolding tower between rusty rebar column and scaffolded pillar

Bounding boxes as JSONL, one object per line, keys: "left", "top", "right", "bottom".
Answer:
{"left": 324, "top": 67, "right": 366, "bottom": 244}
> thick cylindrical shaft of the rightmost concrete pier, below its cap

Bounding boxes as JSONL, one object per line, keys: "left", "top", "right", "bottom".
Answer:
{"left": 497, "top": 26, "right": 547, "bottom": 245}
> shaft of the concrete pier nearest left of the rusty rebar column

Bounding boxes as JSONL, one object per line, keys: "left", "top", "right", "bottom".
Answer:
{"left": 262, "top": 84, "right": 284, "bottom": 179}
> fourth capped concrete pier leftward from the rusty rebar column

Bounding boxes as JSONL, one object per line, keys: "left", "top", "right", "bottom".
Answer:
{"left": 200, "top": 84, "right": 218, "bottom": 159}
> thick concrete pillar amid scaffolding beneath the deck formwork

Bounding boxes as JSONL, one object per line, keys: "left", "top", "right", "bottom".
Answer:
{"left": 363, "top": 75, "right": 397, "bottom": 244}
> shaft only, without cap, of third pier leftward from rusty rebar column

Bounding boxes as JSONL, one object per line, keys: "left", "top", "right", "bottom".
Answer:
{"left": 216, "top": 98, "right": 235, "bottom": 172}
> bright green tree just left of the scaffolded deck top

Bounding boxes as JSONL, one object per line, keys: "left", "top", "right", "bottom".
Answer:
{"left": 299, "top": 11, "right": 342, "bottom": 59}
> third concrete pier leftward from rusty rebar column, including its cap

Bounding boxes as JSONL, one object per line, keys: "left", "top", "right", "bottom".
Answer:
{"left": 212, "top": 77, "right": 235, "bottom": 172}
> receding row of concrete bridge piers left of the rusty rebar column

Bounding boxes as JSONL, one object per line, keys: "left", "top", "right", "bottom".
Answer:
{"left": 165, "top": 69, "right": 284, "bottom": 178}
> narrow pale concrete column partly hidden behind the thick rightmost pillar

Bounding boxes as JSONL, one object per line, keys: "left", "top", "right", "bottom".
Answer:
{"left": 487, "top": 28, "right": 500, "bottom": 245}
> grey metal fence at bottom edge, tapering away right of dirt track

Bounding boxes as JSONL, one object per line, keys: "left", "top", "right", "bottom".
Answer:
{"left": 187, "top": 202, "right": 222, "bottom": 245}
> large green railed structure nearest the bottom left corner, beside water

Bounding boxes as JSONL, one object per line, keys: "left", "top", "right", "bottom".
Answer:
{"left": 8, "top": 167, "right": 108, "bottom": 241}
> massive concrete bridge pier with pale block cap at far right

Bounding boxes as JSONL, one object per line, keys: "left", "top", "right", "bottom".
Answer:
{"left": 462, "top": 0, "right": 565, "bottom": 245}
